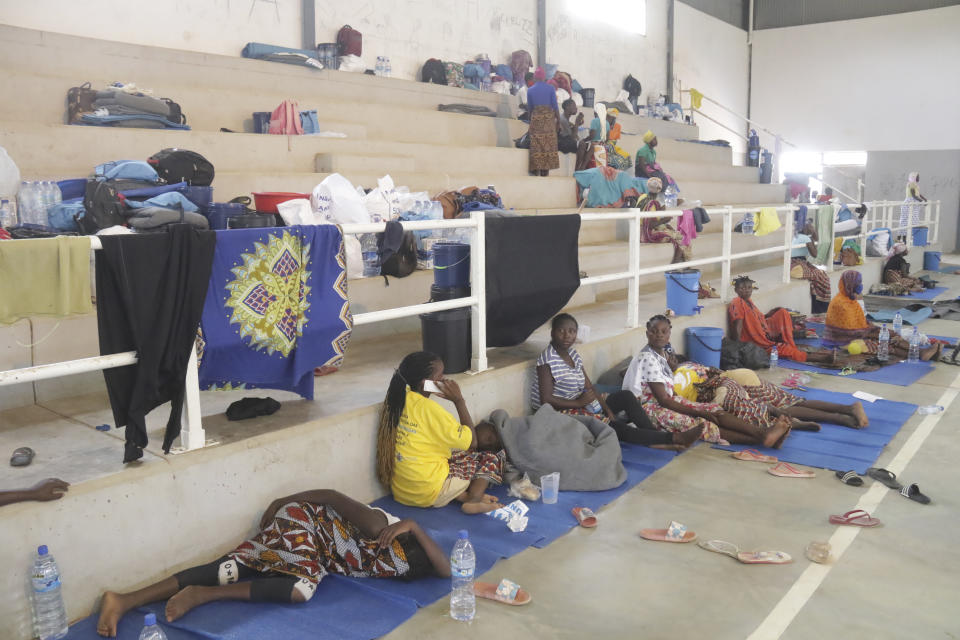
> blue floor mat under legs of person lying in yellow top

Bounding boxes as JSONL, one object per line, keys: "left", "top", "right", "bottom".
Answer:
{"left": 714, "top": 389, "right": 917, "bottom": 474}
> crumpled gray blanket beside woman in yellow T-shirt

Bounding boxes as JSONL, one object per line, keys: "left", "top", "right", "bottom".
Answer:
{"left": 490, "top": 405, "right": 627, "bottom": 491}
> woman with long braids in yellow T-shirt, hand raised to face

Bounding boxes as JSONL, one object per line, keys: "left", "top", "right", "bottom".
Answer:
{"left": 377, "top": 351, "right": 505, "bottom": 514}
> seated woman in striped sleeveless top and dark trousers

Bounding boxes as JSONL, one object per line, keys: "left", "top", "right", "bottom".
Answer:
{"left": 530, "top": 313, "right": 703, "bottom": 448}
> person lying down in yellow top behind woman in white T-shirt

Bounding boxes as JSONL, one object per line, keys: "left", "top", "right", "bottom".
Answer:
{"left": 674, "top": 362, "right": 870, "bottom": 431}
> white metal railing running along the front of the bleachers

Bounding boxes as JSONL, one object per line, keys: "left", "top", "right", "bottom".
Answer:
{"left": 0, "top": 201, "right": 940, "bottom": 451}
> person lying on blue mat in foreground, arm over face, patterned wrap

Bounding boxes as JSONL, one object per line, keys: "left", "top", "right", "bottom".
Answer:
{"left": 97, "top": 489, "right": 450, "bottom": 638}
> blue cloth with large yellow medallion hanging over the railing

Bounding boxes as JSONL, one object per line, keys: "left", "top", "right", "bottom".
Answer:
{"left": 197, "top": 225, "right": 353, "bottom": 400}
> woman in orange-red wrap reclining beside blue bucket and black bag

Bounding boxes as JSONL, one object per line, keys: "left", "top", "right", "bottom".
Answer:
{"left": 727, "top": 276, "right": 836, "bottom": 363}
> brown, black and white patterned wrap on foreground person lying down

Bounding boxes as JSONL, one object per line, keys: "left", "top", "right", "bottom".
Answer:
{"left": 227, "top": 502, "right": 416, "bottom": 584}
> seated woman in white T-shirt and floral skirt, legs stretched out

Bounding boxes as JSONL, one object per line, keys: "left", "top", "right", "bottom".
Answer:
{"left": 623, "top": 315, "right": 790, "bottom": 448}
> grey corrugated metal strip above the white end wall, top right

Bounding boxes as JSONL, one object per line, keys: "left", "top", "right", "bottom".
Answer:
{"left": 756, "top": 0, "right": 960, "bottom": 29}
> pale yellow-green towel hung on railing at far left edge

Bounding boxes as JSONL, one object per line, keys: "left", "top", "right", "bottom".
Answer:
{"left": 0, "top": 236, "right": 93, "bottom": 324}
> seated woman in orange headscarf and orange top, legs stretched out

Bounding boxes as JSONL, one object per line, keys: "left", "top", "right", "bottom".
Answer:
{"left": 823, "top": 270, "right": 943, "bottom": 364}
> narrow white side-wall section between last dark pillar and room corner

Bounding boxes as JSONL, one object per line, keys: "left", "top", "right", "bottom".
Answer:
{"left": 673, "top": 2, "right": 749, "bottom": 158}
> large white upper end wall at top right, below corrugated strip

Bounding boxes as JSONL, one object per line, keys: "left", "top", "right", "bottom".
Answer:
{"left": 752, "top": 6, "right": 960, "bottom": 151}
